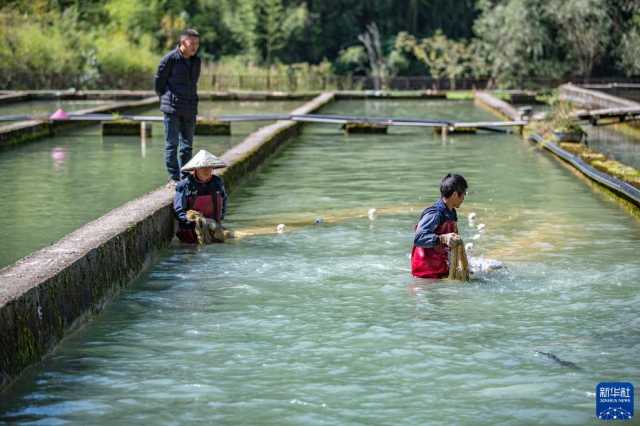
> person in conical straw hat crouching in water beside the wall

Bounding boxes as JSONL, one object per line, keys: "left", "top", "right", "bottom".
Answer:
{"left": 173, "top": 149, "right": 227, "bottom": 244}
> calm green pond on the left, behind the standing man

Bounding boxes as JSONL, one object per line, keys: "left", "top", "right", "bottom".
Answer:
{"left": 0, "top": 101, "right": 302, "bottom": 268}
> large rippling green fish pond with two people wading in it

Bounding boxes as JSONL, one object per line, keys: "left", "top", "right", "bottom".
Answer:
{"left": 0, "top": 101, "right": 640, "bottom": 425}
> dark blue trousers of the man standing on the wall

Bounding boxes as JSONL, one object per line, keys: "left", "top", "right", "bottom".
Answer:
{"left": 164, "top": 113, "right": 196, "bottom": 181}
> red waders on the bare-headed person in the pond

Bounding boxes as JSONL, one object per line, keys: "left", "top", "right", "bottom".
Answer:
{"left": 411, "top": 220, "right": 458, "bottom": 278}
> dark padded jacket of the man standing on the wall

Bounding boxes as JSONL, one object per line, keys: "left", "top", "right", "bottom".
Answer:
{"left": 155, "top": 47, "right": 200, "bottom": 115}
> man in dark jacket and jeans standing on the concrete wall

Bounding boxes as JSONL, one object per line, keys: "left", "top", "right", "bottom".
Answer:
{"left": 155, "top": 29, "right": 200, "bottom": 182}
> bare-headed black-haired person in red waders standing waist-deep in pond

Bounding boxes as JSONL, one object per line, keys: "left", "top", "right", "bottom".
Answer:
{"left": 411, "top": 174, "right": 467, "bottom": 278}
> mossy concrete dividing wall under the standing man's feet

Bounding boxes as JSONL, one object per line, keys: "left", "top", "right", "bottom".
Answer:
{"left": 0, "top": 93, "right": 334, "bottom": 391}
